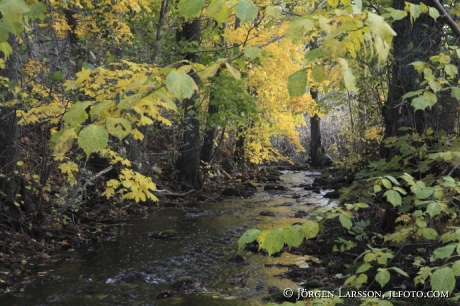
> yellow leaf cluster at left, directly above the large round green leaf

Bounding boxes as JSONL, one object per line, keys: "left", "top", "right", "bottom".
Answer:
{"left": 65, "top": 61, "right": 176, "bottom": 131}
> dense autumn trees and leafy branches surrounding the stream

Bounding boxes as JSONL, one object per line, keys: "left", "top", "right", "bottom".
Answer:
{"left": 0, "top": 0, "right": 460, "bottom": 305}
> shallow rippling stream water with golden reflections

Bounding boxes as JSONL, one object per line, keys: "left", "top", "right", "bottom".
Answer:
{"left": 0, "top": 171, "right": 334, "bottom": 306}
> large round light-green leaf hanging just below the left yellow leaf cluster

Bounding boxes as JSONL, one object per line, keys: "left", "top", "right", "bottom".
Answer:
{"left": 78, "top": 124, "right": 109, "bottom": 157}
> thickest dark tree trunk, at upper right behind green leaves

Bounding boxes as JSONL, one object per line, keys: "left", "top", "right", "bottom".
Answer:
{"left": 382, "top": 0, "right": 441, "bottom": 143}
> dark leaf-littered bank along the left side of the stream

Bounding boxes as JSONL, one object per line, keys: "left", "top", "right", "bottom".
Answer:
{"left": 0, "top": 169, "right": 318, "bottom": 293}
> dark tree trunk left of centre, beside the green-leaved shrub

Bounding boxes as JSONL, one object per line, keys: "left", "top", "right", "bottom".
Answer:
{"left": 176, "top": 19, "right": 203, "bottom": 189}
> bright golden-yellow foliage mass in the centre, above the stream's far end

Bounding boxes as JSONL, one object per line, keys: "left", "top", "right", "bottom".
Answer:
{"left": 227, "top": 22, "right": 315, "bottom": 163}
